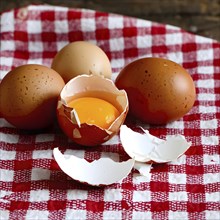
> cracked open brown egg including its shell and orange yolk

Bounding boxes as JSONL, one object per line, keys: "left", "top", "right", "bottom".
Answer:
{"left": 57, "top": 75, "right": 128, "bottom": 146}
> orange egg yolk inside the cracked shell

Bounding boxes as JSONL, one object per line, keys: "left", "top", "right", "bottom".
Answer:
{"left": 68, "top": 97, "right": 120, "bottom": 129}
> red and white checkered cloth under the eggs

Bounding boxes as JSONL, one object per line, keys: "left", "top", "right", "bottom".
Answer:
{"left": 0, "top": 5, "right": 220, "bottom": 220}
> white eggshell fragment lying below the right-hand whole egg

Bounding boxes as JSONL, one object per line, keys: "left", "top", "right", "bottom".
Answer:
{"left": 120, "top": 125, "right": 191, "bottom": 163}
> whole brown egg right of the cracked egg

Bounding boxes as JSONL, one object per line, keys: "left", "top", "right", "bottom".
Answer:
{"left": 115, "top": 58, "right": 196, "bottom": 124}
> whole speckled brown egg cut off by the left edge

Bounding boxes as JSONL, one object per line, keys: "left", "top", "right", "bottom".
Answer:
{"left": 0, "top": 64, "right": 65, "bottom": 129}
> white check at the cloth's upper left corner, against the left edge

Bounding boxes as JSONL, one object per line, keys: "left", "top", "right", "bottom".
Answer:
{"left": 0, "top": 11, "right": 14, "bottom": 33}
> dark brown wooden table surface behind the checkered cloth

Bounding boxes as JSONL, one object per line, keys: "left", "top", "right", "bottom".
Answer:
{"left": 0, "top": 0, "right": 220, "bottom": 41}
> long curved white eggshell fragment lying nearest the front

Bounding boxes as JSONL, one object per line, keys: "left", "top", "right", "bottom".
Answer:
{"left": 53, "top": 148, "right": 134, "bottom": 186}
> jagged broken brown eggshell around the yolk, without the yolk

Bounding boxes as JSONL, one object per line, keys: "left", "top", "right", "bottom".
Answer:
{"left": 57, "top": 75, "right": 128, "bottom": 146}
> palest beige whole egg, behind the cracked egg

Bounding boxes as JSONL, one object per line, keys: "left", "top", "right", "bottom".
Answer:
{"left": 51, "top": 41, "right": 112, "bottom": 82}
